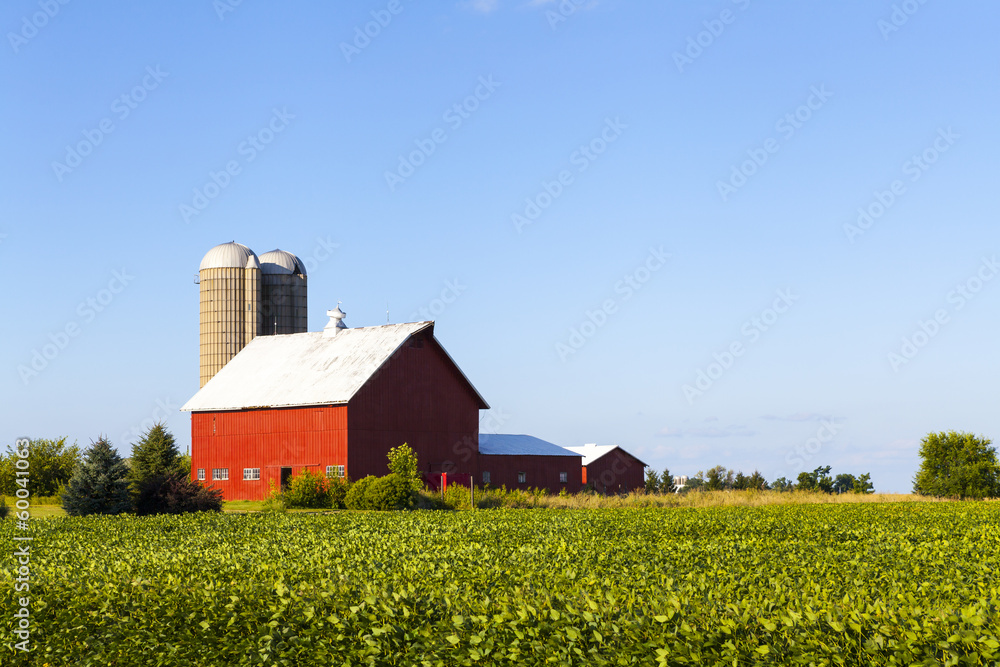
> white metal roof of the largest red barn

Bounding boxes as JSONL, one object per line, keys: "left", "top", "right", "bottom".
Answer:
{"left": 181, "top": 322, "right": 486, "bottom": 412}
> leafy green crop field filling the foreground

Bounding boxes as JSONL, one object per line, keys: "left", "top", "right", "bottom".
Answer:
{"left": 0, "top": 503, "right": 1000, "bottom": 667}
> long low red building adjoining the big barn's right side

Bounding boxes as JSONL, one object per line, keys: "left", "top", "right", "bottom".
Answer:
{"left": 477, "top": 433, "right": 582, "bottom": 493}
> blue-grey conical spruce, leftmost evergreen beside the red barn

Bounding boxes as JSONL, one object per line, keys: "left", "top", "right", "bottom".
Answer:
{"left": 62, "top": 437, "right": 131, "bottom": 516}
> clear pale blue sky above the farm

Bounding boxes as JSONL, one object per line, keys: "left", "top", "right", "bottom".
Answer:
{"left": 0, "top": 0, "right": 1000, "bottom": 492}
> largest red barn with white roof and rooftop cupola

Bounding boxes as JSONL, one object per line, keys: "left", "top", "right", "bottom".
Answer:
{"left": 181, "top": 315, "right": 489, "bottom": 500}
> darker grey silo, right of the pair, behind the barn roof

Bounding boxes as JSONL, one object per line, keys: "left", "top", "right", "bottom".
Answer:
{"left": 260, "top": 250, "right": 309, "bottom": 336}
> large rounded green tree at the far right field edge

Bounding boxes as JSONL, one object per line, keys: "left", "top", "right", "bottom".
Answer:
{"left": 913, "top": 431, "right": 1000, "bottom": 498}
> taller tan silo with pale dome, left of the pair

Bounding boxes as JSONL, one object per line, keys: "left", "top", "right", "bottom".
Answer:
{"left": 198, "top": 242, "right": 262, "bottom": 387}
